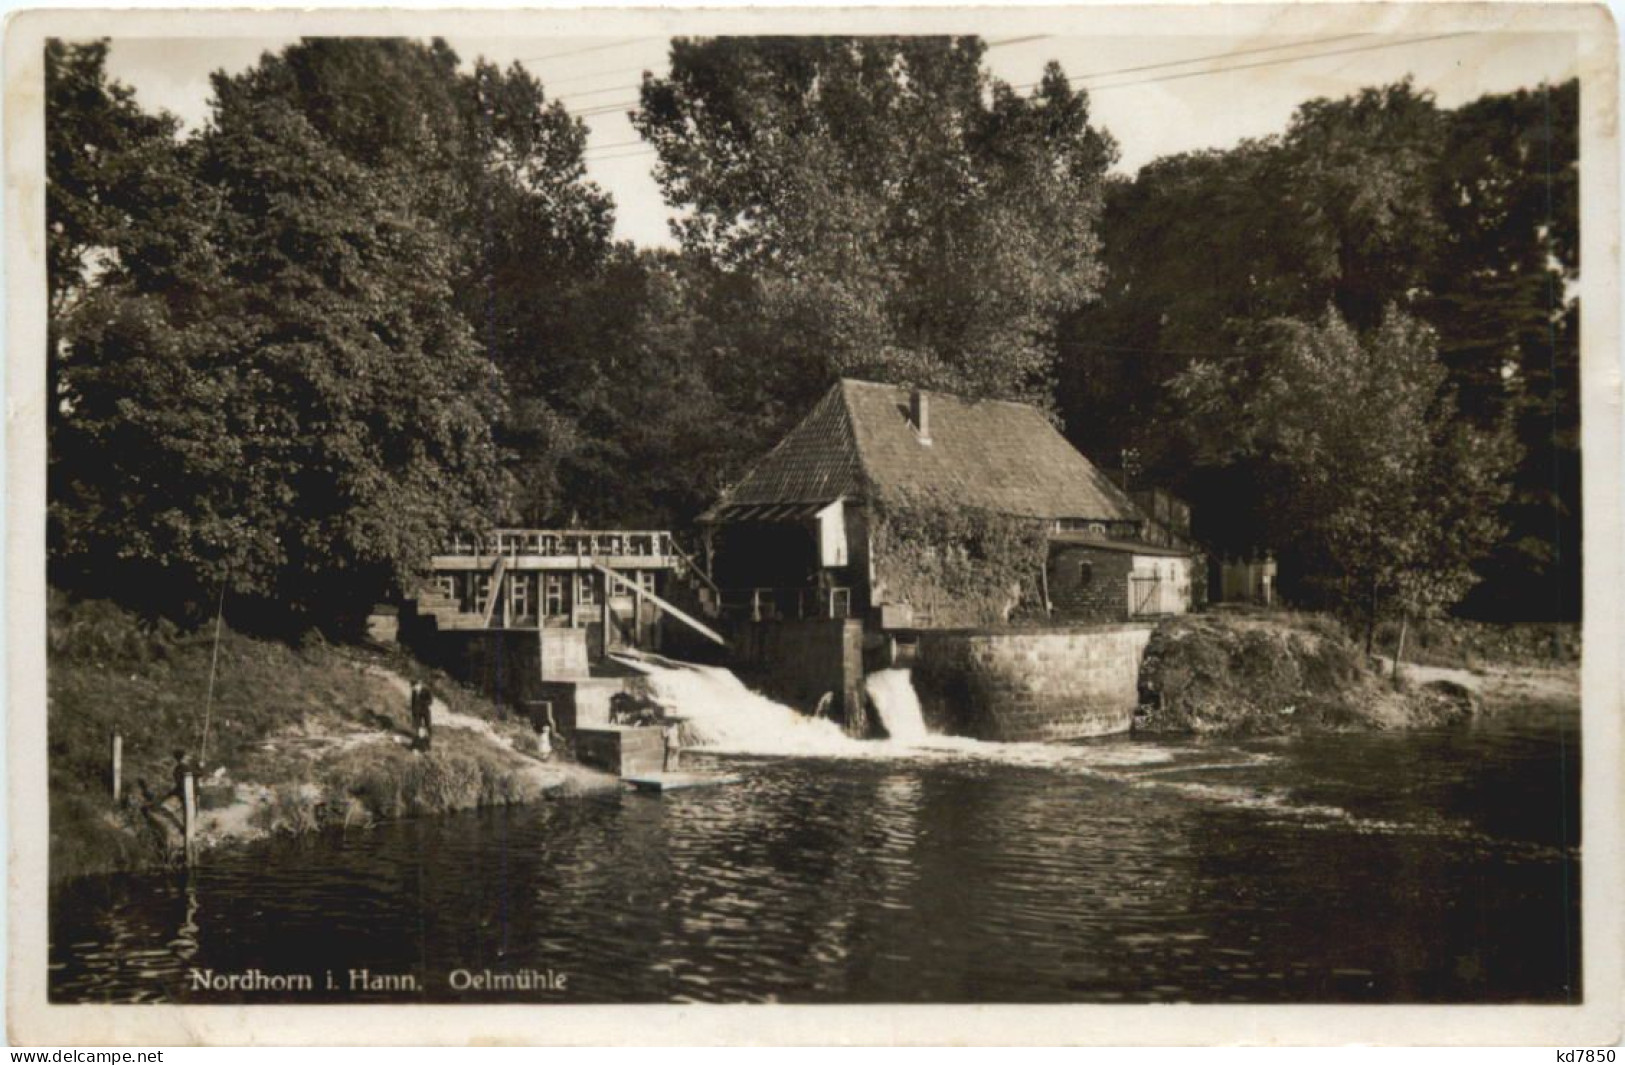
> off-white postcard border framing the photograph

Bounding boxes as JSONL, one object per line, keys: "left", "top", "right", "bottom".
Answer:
{"left": 5, "top": 2, "right": 1625, "bottom": 1045}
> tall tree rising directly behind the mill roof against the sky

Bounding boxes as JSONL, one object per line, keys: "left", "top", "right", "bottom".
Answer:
{"left": 634, "top": 37, "right": 1115, "bottom": 406}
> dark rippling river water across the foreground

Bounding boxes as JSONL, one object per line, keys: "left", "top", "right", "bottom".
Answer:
{"left": 50, "top": 678, "right": 1581, "bottom": 1003}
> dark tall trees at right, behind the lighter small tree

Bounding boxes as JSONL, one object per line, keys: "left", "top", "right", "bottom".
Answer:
{"left": 1058, "top": 81, "right": 1580, "bottom": 616}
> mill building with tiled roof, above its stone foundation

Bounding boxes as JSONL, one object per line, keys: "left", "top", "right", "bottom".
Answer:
{"left": 700, "top": 380, "right": 1193, "bottom": 631}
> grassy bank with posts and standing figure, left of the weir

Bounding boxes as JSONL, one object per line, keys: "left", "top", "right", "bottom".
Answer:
{"left": 47, "top": 592, "right": 614, "bottom": 878}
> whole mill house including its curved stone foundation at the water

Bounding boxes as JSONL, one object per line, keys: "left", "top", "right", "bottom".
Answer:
{"left": 699, "top": 380, "right": 1199, "bottom": 740}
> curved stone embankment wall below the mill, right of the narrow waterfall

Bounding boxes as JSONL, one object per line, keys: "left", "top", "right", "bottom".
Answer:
{"left": 913, "top": 623, "right": 1155, "bottom": 743}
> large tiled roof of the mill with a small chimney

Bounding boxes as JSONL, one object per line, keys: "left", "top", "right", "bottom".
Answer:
{"left": 704, "top": 380, "right": 1144, "bottom": 522}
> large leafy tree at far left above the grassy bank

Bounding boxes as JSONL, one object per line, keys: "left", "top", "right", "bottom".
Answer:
{"left": 50, "top": 79, "right": 505, "bottom": 621}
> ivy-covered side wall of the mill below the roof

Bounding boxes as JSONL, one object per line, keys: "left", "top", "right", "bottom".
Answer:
{"left": 869, "top": 501, "right": 1048, "bottom": 628}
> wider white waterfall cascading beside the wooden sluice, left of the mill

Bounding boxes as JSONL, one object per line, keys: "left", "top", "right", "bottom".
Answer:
{"left": 614, "top": 654, "right": 865, "bottom": 754}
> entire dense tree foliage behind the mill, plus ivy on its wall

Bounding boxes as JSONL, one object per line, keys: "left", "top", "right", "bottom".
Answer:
{"left": 46, "top": 37, "right": 1580, "bottom": 618}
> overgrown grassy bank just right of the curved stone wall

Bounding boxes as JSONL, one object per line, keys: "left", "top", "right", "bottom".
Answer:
{"left": 1136, "top": 611, "right": 1480, "bottom": 733}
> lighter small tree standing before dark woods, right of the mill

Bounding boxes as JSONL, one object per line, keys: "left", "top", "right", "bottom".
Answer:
{"left": 1172, "top": 307, "right": 1513, "bottom": 644}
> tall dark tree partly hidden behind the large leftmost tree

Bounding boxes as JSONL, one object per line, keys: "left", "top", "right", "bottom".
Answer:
{"left": 215, "top": 37, "right": 614, "bottom": 524}
